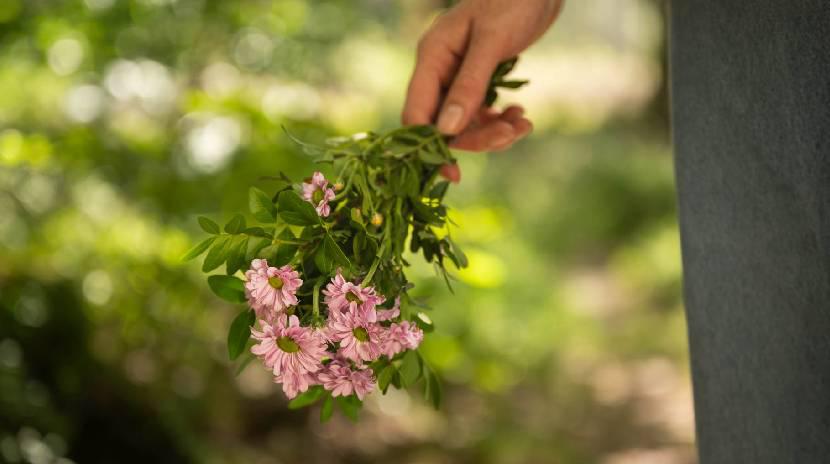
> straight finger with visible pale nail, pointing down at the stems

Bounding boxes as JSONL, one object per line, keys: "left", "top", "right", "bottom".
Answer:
{"left": 437, "top": 33, "right": 501, "bottom": 135}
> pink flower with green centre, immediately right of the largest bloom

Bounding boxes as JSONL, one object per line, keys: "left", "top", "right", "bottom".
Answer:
{"left": 326, "top": 311, "right": 385, "bottom": 363}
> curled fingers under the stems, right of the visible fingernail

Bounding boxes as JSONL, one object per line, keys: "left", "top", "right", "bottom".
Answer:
{"left": 450, "top": 106, "right": 533, "bottom": 151}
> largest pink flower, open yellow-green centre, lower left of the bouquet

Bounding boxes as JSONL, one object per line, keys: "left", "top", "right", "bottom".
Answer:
{"left": 251, "top": 316, "right": 328, "bottom": 399}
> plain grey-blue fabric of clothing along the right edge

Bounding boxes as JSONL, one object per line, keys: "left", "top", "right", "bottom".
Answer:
{"left": 670, "top": 0, "right": 830, "bottom": 464}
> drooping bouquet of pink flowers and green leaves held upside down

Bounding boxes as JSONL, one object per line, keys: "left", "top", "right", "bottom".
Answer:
{"left": 185, "top": 58, "right": 524, "bottom": 421}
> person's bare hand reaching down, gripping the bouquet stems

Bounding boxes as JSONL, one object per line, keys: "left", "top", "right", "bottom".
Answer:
{"left": 402, "top": 0, "right": 563, "bottom": 181}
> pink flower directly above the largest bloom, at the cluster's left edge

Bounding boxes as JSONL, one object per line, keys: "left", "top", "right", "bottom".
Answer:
{"left": 245, "top": 259, "right": 303, "bottom": 321}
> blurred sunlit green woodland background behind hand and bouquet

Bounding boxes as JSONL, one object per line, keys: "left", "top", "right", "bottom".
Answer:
{"left": 0, "top": 0, "right": 695, "bottom": 464}
